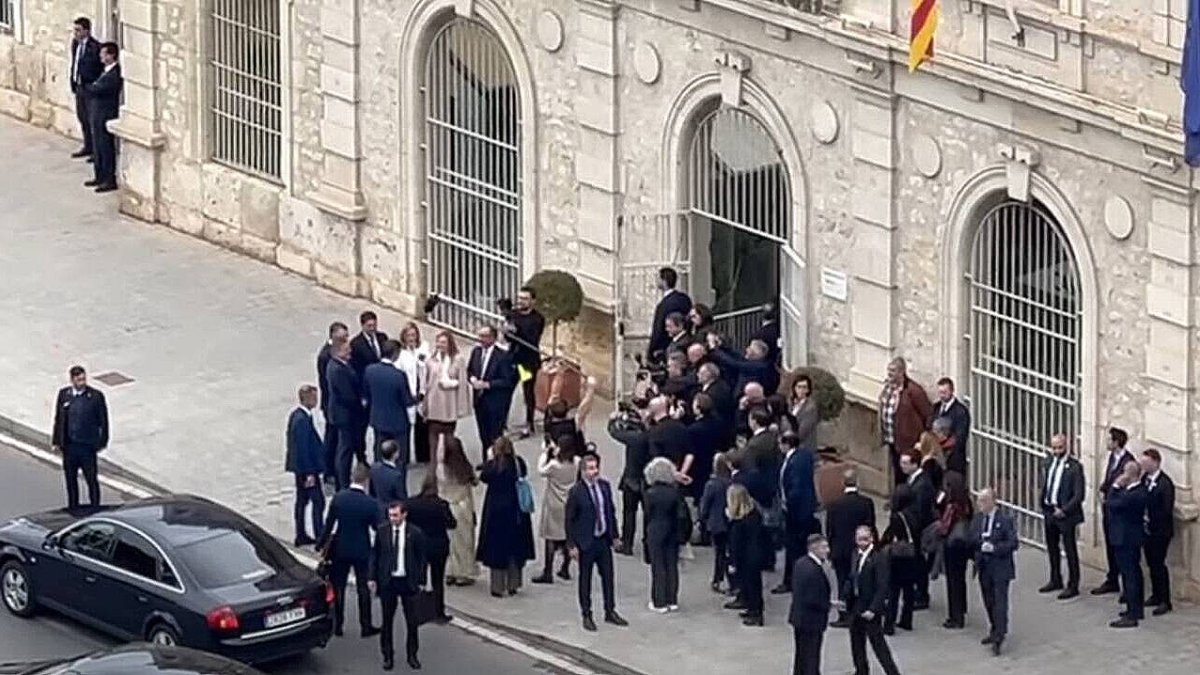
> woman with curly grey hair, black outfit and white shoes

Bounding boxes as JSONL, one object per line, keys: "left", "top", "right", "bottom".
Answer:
{"left": 642, "top": 458, "right": 688, "bottom": 614}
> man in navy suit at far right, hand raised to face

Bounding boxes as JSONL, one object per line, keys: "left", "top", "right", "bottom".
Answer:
{"left": 1104, "top": 461, "right": 1147, "bottom": 628}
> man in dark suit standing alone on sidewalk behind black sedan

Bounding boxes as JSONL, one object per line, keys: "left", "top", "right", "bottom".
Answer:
{"left": 50, "top": 365, "right": 108, "bottom": 509}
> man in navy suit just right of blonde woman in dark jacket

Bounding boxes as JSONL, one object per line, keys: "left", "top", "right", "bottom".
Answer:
{"left": 770, "top": 432, "right": 821, "bottom": 595}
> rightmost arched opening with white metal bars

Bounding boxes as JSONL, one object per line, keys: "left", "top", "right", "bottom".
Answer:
{"left": 966, "top": 199, "right": 1084, "bottom": 543}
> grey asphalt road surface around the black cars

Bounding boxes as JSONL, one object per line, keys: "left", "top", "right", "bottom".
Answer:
{"left": 0, "top": 446, "right": 551, "bottom": 675}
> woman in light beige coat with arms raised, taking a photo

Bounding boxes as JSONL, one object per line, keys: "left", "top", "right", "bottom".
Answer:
{"left": 533, "top": 434, "right": 581, "bottom": 584}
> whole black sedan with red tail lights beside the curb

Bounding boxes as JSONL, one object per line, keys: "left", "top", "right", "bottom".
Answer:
{"left": 0, "top": 495, "right": 334, "bottom": 663}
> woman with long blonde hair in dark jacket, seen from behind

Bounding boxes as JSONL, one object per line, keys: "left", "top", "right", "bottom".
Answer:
{"left": 725, "top": 483, "right": 766, "bottom": 626}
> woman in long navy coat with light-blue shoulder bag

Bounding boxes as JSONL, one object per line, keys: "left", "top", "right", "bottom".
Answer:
{"left": 475, "top": 436, "right": 534, "bottom": 598}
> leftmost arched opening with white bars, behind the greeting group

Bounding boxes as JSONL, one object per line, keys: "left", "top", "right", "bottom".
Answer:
{"left": 422, "top": 17, "right": 524, "bottom": 331}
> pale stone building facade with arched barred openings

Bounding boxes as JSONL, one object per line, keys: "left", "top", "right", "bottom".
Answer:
{"left": 7, "top": 0, "right": 1200, "bottom": 593}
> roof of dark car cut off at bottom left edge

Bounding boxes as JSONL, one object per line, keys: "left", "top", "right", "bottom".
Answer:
{"left": 0, "top": 644, "right": 262, "bottom": 675}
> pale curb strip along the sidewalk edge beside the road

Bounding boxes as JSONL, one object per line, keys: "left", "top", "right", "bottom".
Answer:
{"left": 0, "top": 416, "right": 646, "bottom": 675}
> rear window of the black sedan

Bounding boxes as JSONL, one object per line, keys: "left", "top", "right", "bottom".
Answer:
{"left": 176, "top": 530, "right": 294, "bottom": 589}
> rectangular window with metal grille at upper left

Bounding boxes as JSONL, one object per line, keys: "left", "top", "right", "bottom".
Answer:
{"left": 209, "top": 0, "right": 284, "bottom": 181}
